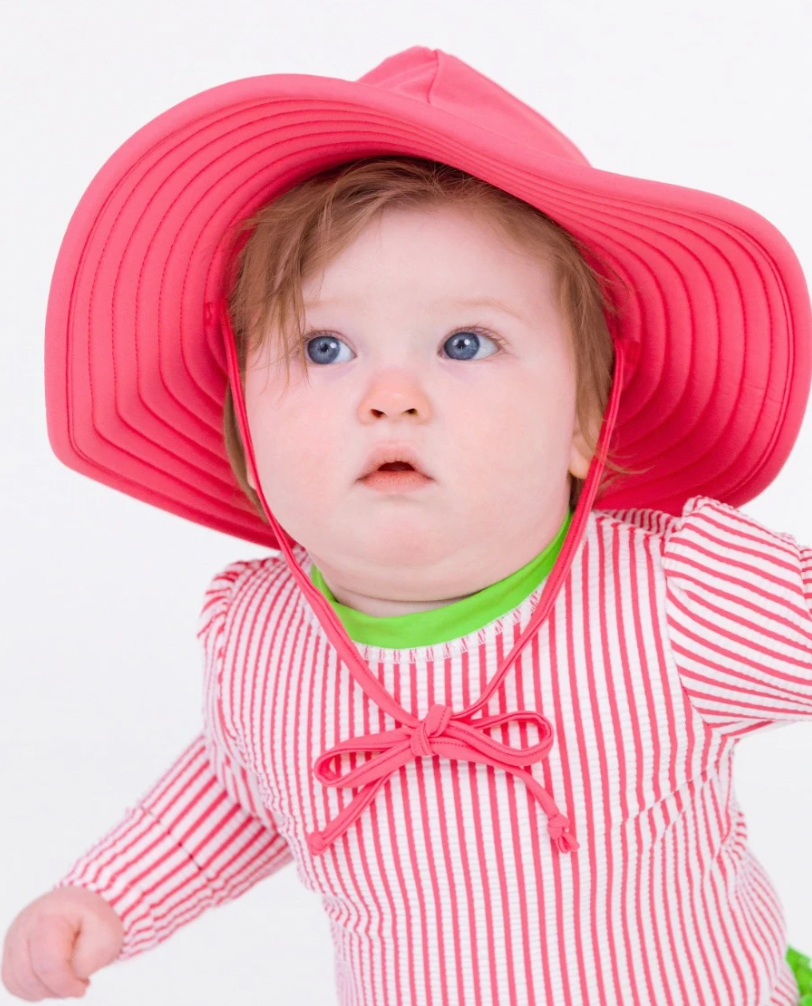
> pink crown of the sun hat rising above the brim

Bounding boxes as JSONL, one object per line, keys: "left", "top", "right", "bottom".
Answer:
{"left": 357, "top": 45, "right": 589, "bottom": 165}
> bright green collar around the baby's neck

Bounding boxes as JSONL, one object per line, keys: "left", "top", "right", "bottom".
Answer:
{"left": 310, "top": 510, "right": 573, "bottom": 650}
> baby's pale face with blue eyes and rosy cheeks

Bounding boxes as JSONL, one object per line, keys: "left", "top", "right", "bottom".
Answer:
{"left": 246, "top": 207, "right": 589, "bottom": 616}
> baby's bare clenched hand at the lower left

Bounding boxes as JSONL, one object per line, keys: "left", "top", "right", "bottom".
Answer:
{"left": 2, "top": 887, "right": 124, "bottom": 1002}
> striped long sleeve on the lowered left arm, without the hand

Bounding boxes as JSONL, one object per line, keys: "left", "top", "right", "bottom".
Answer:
{"left": 53, "top": 560, "right": 292, "bottom": 960}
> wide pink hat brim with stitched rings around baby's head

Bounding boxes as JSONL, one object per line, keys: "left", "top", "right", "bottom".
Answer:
{"left": 45, "top": 74, "right": 812, "bottom": 548}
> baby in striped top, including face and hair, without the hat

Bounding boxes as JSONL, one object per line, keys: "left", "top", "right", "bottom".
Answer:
{"left": 2, "top": 49, "right": 812, "bottom": 1006}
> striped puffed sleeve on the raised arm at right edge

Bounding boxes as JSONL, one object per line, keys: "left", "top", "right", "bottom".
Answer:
{"left": 662, "top": 496, "right": 812, "bottom": 735}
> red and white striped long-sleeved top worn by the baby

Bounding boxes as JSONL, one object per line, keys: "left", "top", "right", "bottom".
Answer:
{"left": 56, "top": 496, "right": 812, "bottom": 1006}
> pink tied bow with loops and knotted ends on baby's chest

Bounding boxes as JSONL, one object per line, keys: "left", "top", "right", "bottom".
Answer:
{"left": 307, "top": 703, "right": 579, "bottom": 855}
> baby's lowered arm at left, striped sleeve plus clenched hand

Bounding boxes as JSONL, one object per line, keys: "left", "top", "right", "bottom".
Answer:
{"left": 2, "top": 733, "right": 290, "bottom": 1000}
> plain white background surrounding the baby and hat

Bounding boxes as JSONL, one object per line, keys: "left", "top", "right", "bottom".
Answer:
{"left": 0, "top": 0, "right": 812, "bottom": 1006}
